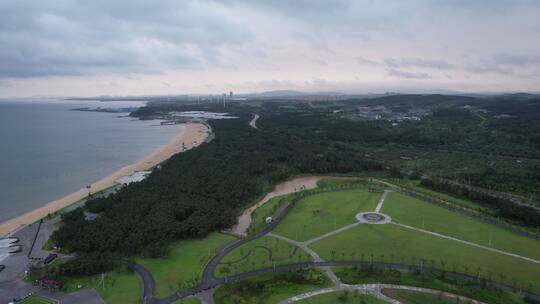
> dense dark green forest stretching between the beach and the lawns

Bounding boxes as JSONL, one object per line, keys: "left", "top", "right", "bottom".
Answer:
{"left": 53, "top": 96, "right": 540, "bottom": 274}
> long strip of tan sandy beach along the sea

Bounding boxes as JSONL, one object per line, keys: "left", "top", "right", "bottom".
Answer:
{"left": 0, "top": 123, "right": 208, "bottom": 237}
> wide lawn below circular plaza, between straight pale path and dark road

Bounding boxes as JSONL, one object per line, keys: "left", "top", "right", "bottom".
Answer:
{"left": 311, "top": 224, "right": 540, "bottom": 292}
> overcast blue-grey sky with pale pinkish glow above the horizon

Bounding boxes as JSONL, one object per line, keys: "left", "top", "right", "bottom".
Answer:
{"left": 0, "top": 0, "right": 540, "bottom": 98}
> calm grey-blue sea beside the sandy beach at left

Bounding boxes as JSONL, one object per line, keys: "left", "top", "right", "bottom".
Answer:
{"left": 0, "top": 101, "right": 182, "bottom": 222}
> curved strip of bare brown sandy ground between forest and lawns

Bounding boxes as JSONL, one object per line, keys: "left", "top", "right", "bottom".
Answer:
{"left": 231, "top": 176, "right": 351, "bottom": 235}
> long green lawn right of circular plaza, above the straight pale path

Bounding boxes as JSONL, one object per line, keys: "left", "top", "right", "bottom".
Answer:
{"left": 381, "top": 192, "right": 540, "bottom": 260}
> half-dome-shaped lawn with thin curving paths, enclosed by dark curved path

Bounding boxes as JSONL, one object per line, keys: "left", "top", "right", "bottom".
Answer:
{"left": 216, "top": 236, "right": 311, "bottom": 276}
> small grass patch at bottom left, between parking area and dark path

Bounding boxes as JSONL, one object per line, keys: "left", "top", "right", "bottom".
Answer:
{"left": 64, "top": 270, "right": 143, "bottom": 304}
